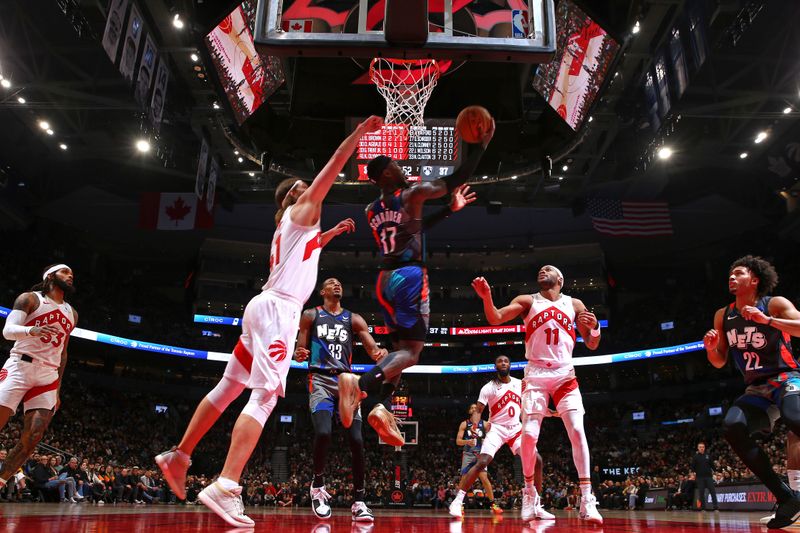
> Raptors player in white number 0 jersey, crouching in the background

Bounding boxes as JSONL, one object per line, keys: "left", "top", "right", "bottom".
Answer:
{"left": 450, "top": 355, "right": 555, "bottom": 520}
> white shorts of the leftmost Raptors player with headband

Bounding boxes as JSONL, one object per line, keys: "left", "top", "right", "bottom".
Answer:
{"left": 0, "top": 357, "right": 58, "bottom": 412}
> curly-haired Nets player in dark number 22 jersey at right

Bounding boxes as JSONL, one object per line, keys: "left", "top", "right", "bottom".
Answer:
{"left": 703, "top": 255, "right": 800, "bottom": 529}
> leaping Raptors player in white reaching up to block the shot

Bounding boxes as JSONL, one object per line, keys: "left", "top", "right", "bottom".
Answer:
{"left": 157, "top": 117, "right": 383, "bottom": 527}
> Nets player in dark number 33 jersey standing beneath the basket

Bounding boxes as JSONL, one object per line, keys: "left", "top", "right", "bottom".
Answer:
{"left": 294, "top": 278, "right": 387, "bottom": 522}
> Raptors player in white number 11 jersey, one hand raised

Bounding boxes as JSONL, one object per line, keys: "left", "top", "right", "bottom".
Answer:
{"left": 472, "top": 265, "right": 603, "bottom": 524}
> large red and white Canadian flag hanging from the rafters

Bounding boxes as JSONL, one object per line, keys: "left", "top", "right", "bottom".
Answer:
{"left": 139, "top": 191, "right": 214, "bottom": 230}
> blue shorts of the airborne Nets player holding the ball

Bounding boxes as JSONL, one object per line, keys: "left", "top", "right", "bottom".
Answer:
{"left": 375, "top": 265, "right": 431, "bottom": 341}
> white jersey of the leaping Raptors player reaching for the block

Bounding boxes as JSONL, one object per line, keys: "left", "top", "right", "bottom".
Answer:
{"left": 262, "top": 206, "right": 322, "bottom": 305}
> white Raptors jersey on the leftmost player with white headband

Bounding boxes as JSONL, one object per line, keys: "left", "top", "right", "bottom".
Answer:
{"left": 11, "top": 291, "right": 75, "bottom": 367}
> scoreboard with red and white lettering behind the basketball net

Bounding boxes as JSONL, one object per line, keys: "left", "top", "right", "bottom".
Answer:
{"left": 350, "top": 118, "right": 462, "bottom": 181}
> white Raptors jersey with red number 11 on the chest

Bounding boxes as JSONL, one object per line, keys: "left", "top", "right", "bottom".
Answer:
{"left": 525, "top": 292, "right": 575, "bottom": 368}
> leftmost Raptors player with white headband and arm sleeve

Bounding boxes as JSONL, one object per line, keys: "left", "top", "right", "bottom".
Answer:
{"left": 0, "top": 264, "right": 78, "bottom": 489}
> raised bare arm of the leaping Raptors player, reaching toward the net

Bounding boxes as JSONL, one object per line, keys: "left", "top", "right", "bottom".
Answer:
{"left": 292, "top": 115, "right": 383, "bottom": 226}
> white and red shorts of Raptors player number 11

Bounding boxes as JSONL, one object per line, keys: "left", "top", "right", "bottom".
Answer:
{"left": 522, "top": 364, "right": 586, "bottom": 416}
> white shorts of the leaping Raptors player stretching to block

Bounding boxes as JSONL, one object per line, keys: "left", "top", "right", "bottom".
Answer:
{"left": 236, "top": 290, "right": 303, "bottom": 396}
